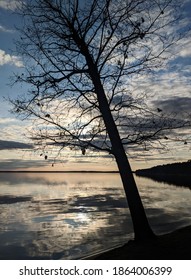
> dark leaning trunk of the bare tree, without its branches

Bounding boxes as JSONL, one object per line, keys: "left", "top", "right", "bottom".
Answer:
{"left": 89, "top": 61, "right": 155, "bottom": 241}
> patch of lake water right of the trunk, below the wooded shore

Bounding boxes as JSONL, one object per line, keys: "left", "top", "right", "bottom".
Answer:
{"left": 136, "top": 177, "right": 191, "bottom": 233}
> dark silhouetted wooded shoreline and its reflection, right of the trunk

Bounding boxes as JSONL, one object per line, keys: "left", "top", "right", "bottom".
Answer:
{"left": 135, "top": 160, "right": 191, "bottom": 189}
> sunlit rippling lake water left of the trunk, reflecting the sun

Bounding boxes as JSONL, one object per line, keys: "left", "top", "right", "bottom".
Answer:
{"left": 0, "top": 173, "right": 132, "bottom": 259}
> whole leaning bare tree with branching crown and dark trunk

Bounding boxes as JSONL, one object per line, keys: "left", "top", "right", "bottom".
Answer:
{"left": 12, "top": 0, "right": 188, "bottom": 240}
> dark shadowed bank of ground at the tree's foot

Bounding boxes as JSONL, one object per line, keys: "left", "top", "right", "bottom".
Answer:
{"left": 93, "top": 226, "right": 191, "bottom": 260}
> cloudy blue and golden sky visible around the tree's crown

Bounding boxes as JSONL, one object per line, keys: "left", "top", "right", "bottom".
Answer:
{"left": 0, "top": 0, "right": 191, "bottom": 171}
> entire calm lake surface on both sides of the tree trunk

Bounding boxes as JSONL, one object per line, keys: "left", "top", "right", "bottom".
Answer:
{"left": 0, "top": 173, "right": 191, "bottom": 259}
